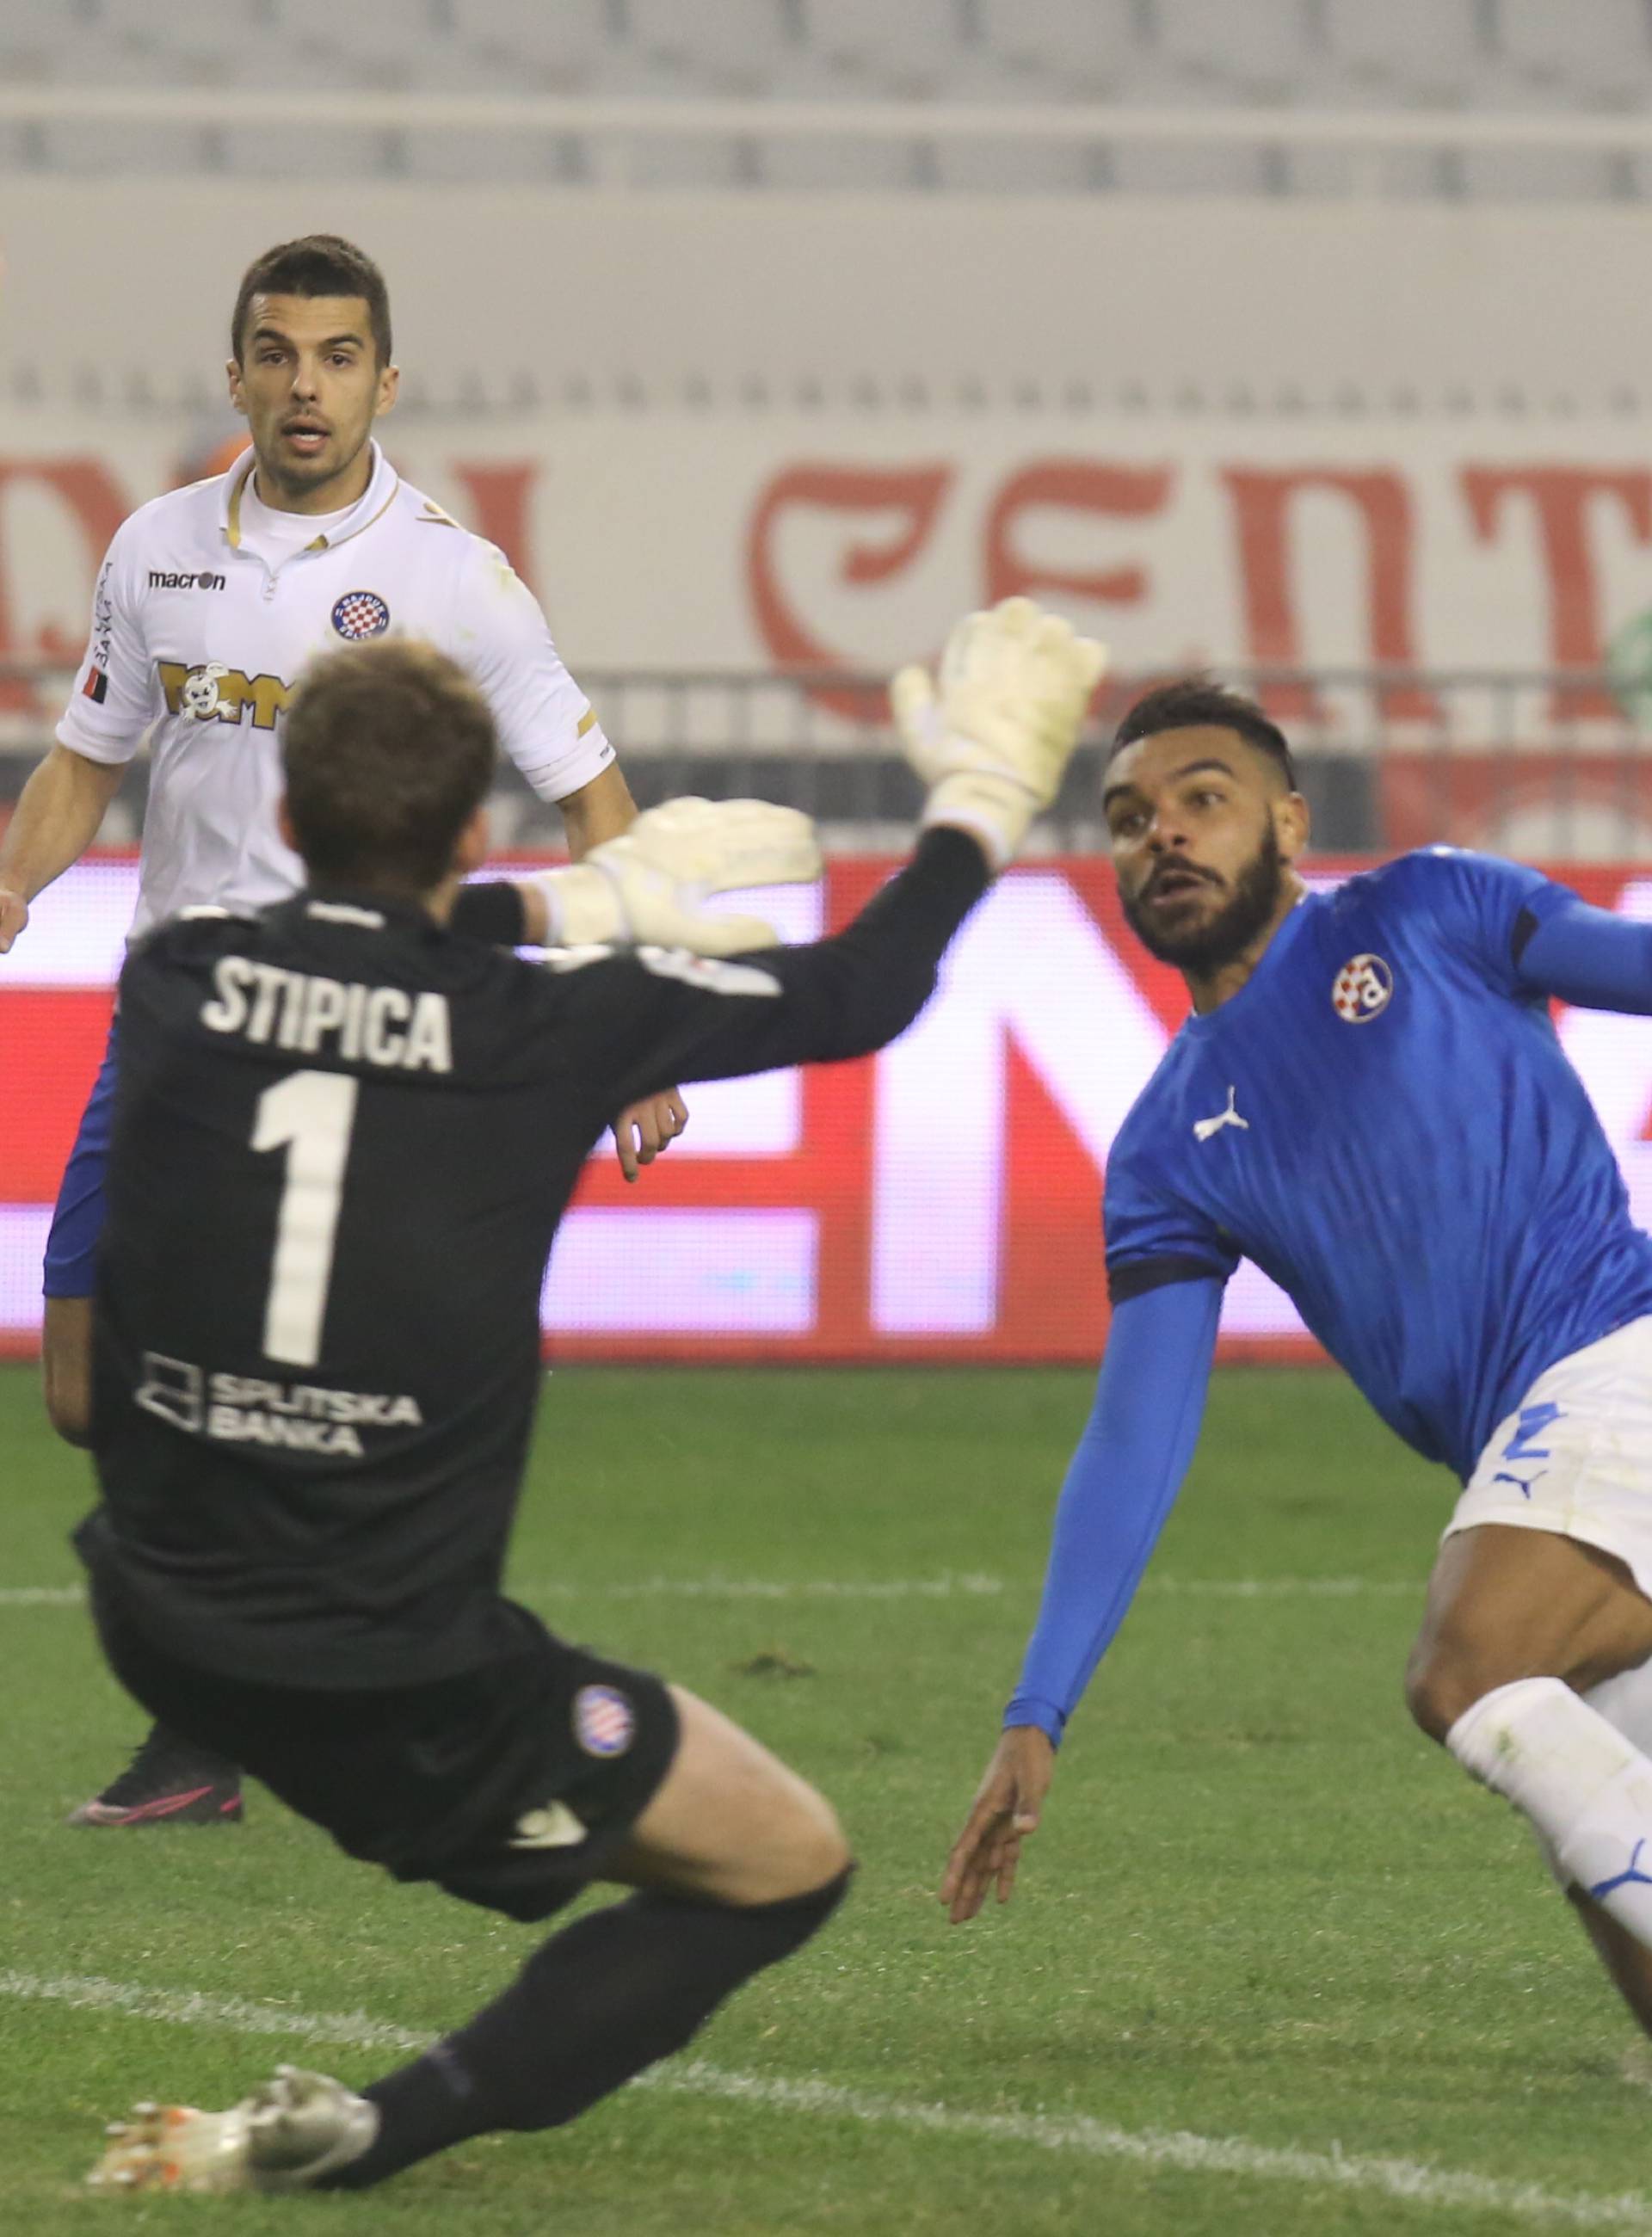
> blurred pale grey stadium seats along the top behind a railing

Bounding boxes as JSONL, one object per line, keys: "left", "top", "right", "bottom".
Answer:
{"left": 0, "top": 0, "right": 1652, "bottom": 201}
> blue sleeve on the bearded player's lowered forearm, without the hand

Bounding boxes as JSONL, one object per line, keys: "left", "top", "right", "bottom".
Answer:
{"left": 1003, "top": 1282, "right": 1222, "bottom": 1742}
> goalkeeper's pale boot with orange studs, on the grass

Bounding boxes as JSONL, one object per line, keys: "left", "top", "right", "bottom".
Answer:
{"left": 87, "top": 2067, "right": 379, "bottom": 2192}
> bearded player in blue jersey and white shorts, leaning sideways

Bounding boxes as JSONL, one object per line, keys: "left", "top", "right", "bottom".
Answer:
{"left": 942, "top": 682, "right": 1652, "bottom": 2031}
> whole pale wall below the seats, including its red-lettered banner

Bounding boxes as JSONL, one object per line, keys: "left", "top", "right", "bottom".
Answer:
{"left": 0, "top": 179, "right": 1652, "bottom": 743}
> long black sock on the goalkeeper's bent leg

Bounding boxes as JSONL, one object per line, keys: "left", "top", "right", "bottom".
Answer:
{"left": 317, "top": 1872, "right": 848, "bottom": 2190}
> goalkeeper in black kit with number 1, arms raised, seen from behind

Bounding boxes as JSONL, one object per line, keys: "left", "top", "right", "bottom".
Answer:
{"left": 78, "top": 600, "right": 1101, "bottom": 2192}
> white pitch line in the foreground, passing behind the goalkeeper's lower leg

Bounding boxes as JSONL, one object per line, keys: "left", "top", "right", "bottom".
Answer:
{"left": 0, "top": 1969, "right": 1652, "bottom": 2237}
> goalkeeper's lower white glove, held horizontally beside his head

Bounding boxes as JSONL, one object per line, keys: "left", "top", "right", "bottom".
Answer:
{"left": 524, "top": 798, "right": 822, "bottom": 955}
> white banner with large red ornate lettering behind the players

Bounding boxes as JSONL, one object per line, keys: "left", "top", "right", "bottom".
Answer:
{"left": 0, "top": 411, "right": 1652, "bottom": 727}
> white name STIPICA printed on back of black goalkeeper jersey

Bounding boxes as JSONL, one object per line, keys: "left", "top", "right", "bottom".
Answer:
{"left": 201, "top": 955, "right": 453, "bottom": 1071}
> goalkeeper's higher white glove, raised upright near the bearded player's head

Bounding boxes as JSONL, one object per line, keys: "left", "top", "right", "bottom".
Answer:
{"left": 889, "top": 597, "right": 1108, "bottom": 870}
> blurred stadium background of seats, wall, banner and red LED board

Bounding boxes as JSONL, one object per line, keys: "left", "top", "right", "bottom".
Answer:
{"left": 0, "top": 0, "right": 1652, "bottom": 1360}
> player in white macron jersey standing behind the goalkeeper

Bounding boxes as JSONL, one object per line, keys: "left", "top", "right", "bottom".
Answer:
{"left": 0, "top": 235, "right": 687, "bottom": 1826}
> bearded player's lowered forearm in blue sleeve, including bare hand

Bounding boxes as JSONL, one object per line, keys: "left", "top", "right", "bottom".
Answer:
{"left": 940, "top": 1275, "right": 1222, "bottom": 1926}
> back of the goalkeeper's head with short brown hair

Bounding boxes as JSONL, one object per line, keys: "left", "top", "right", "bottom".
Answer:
{"left": 282, "top": 638, "right": 499, "bottom": 895}
